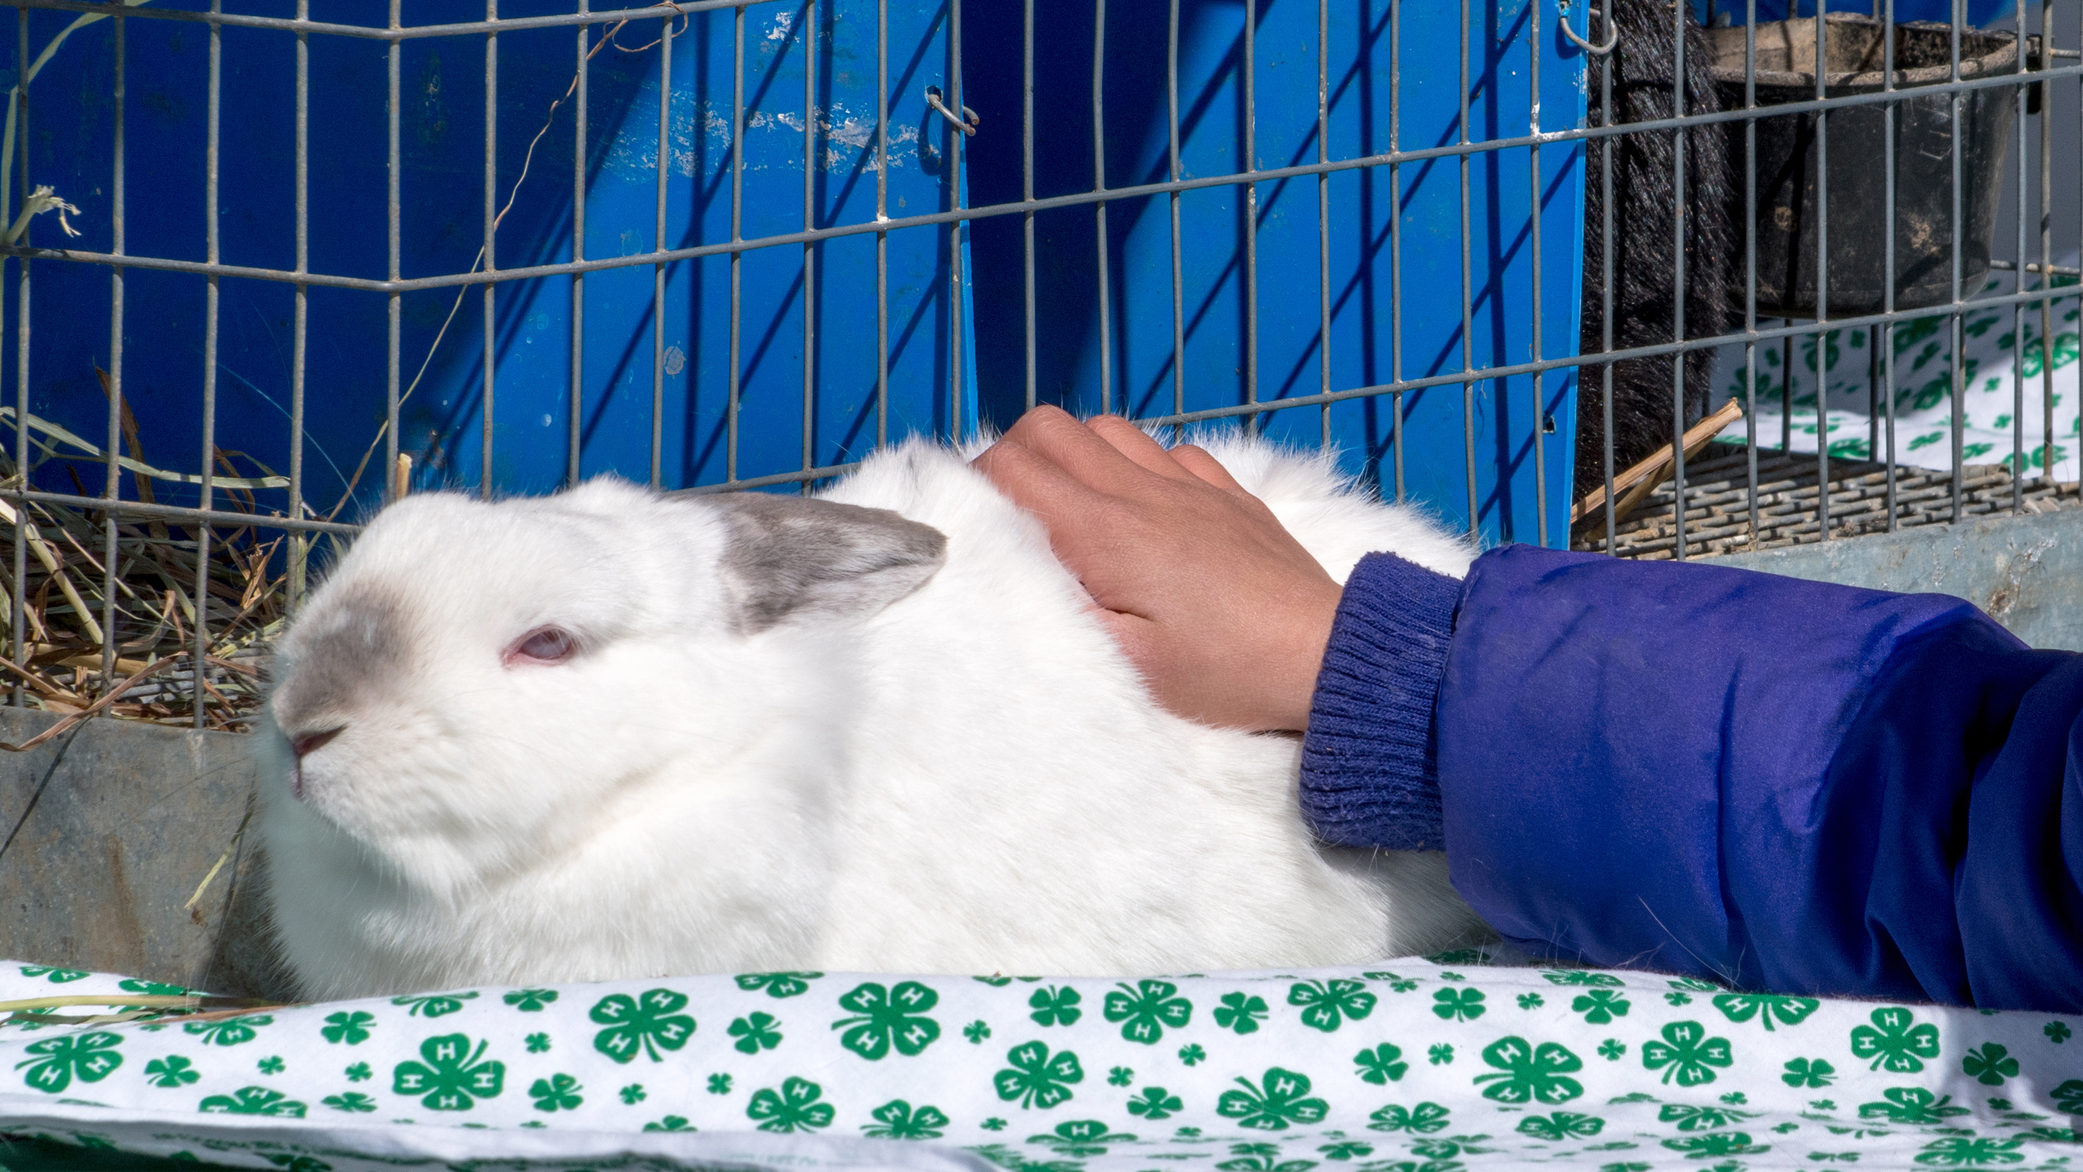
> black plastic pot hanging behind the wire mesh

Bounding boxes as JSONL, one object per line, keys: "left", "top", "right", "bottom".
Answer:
{"left": 1710, "top": 15, "right": 2018, "bottom": 316}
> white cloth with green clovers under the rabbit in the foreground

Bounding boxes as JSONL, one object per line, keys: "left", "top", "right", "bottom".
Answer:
{"left": 0, "top": 953, "right": 2083, "bottom": 1172}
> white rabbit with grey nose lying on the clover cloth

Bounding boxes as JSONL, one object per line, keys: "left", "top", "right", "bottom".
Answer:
{"left": 256, "top": 439, "right": 1483, "bottom": 997}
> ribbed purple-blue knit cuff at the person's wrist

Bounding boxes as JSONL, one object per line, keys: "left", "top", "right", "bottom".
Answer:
{"left": 1302, "top": 554, "right": 1462, "bottom": 851}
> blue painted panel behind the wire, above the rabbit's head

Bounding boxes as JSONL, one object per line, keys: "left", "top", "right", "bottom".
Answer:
{"left": 18, "top": 0, "right": 975, "bottom": 516}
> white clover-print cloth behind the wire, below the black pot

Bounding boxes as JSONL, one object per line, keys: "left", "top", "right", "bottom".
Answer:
{"left": 1712, "top": 256, "right": 2083, "bottom": 481}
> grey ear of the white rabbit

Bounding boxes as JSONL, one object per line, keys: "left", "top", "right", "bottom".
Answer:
{"left": 706, "top": 493, "right": 948, "bottom": 633}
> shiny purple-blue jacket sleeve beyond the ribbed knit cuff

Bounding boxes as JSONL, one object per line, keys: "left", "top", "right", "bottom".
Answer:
{"left": 1312, "top": 545, "right": 2083, "bottom": 1012}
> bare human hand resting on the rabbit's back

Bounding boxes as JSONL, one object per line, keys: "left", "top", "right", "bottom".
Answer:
{"left": 975, "top": 406, "right": 1341, "bottom": 731}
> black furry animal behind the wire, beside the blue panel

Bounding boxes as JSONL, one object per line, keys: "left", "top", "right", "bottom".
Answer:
{"left": 1575, "top": 0, "right": 1737, "bottom": 500}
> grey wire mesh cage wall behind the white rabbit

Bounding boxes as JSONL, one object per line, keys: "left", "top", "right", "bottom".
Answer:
{"left": 0, "top": 0, "right": 2083, "bottom": 729}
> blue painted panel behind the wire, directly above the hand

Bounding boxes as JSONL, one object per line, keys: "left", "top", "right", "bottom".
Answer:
{"left": 964, "top": 0, "right": 1583, "bottom": 541}
